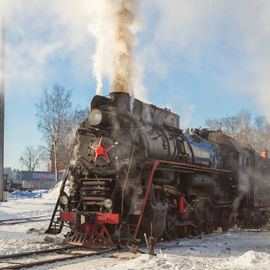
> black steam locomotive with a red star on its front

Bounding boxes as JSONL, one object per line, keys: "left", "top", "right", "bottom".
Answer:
{"left": 47, "top": 92, "right": 270, "bottom": 247}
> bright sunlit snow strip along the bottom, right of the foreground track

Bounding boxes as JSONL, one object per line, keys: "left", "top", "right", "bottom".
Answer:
{"left": 50, "top": 248, "right": 270, "bottom": 270}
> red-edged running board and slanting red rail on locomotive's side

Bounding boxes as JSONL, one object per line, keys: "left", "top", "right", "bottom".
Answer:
{"left": 133, "top": 160, "right": 231, "bottom": 240}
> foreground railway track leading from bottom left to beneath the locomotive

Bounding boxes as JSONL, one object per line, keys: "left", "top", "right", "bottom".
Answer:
{"left": 0, "top": 246, "right": 117, "bottom": 269}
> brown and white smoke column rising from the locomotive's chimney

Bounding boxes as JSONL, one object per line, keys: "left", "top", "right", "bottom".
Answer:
{"left": 91, "top": 0, "right": 138, "bottom": 94}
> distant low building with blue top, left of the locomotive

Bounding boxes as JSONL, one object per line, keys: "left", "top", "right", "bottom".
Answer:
{"left": 21, "top": 171, "right": 55, "bottom": 190}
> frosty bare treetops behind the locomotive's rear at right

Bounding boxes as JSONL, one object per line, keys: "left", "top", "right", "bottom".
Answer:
{"left": 205, "top": 110, "right": 270, "bottom": 153}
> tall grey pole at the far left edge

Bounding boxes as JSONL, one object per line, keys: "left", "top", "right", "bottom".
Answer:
{"left": 0, "top": 12, "right": 6, "bottom": 202}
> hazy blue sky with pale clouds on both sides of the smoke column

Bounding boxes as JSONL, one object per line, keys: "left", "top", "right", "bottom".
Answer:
{"left": 0, "top": 0, "right": 270, "bottom": 168}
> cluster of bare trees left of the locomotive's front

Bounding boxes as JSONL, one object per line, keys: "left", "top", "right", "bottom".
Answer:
{"left": 20, "top": 84, "right": 89, "bottom": 181}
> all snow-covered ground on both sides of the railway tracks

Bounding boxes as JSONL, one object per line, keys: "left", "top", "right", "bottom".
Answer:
{"left": 0, "top": 187, "right": 270, "bottom": 270}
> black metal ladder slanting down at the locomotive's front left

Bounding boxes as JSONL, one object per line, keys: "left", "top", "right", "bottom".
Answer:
{"left": 45, "top": 168, "right": 69, "bottom": 234}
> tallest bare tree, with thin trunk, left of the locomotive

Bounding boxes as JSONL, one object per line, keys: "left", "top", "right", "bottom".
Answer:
{"left": 36, "top": 84, "right": 72, "bottom": 182}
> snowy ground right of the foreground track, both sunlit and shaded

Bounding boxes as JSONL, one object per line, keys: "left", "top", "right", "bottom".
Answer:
{"left": 50, "top": 232, "right": 270, "bottom": 270}
